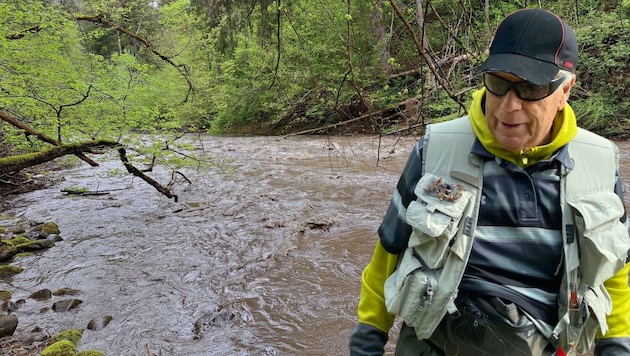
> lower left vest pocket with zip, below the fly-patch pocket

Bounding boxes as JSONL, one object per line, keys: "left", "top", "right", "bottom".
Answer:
{"left": 385, "top": 248, "right": 439, "bottom": 326}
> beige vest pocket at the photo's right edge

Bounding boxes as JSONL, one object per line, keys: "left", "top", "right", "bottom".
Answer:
{"left": 568, "top": 191, "right": 630, "bottom": 286}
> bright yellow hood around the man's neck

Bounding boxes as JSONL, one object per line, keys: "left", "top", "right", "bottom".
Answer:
{"left": 468, "top": 88, "right": 577, "bottom": 168}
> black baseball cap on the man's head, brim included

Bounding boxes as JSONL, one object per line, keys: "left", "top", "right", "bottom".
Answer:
{"left": 477, "top": 9, "right": 578, "bottom": 85}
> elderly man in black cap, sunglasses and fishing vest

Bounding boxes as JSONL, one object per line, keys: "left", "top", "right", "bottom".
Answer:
{"left": 350, "top": 9, "right": 630, "bottom": 356}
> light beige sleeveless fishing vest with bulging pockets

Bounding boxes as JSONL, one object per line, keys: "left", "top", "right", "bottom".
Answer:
{"left": 385, "top": 116, "right": 630, "bottom": 354}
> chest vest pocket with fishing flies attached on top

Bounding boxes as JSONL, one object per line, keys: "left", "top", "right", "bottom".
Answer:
{"left": 406, "top": 174, "right": 472, "bottom": 268}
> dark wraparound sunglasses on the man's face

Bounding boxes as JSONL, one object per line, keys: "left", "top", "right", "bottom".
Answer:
{"left": 483, "top": 73, "right": 565, "bottom": 101}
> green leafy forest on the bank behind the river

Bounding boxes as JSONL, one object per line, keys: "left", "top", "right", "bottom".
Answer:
{"left": 0, "top": 0, "right": 630, "bottom": 192}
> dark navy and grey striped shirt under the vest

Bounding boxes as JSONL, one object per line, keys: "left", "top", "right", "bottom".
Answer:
{"left": 379, "top": 139, "right": 625, "bottom": 325}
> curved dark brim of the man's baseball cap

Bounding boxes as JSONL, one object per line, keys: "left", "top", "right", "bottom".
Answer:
{"left": 477, "top": 53, "right": 559, "bottom": 85}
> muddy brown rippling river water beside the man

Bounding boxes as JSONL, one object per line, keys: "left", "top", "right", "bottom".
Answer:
{"left": 0, "top": 136, "right": 630, "bottom": 355}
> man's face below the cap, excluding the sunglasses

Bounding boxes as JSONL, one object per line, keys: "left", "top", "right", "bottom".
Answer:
{"left": 485, "top": 72, "right": 575, "bottom": 152}
